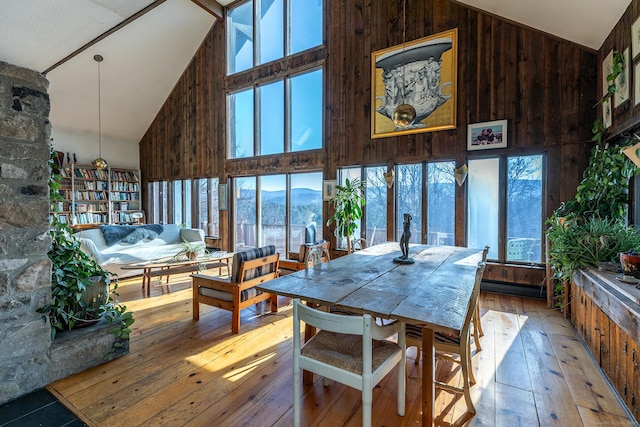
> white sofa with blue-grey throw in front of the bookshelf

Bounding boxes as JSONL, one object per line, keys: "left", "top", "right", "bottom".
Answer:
{"left": 74, "top": 224, "right": 204, "bottom": 277}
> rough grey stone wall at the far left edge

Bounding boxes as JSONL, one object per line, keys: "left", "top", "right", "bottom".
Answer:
{"left": 0, "top": 62, "right": 51, "bottom": 403}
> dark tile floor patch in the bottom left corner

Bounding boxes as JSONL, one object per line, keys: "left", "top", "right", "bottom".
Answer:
{"left": 0, "top": 389, "right": 86, "bottom": 427}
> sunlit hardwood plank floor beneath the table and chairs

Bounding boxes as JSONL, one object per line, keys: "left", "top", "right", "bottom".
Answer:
{"left": 48, "top": 274, "right": 636, "bottom": 427}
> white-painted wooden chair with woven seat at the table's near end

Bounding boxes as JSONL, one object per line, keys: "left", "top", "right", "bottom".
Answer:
{"left": 293, "top": 299, "right": 406, "bottom": 427}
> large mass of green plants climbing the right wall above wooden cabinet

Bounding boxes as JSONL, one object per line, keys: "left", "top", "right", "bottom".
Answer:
{"left": 546, "top": 52, "right": 640, "bottom": 308}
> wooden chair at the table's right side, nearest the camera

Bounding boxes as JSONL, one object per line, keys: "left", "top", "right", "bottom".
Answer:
{"left": 406, "top": 262, "right": 485, "bottom": 414}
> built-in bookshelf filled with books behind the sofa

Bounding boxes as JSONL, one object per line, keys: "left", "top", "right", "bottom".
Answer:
{"left": 52, "top": 164, "right": 142, "bottom": 226}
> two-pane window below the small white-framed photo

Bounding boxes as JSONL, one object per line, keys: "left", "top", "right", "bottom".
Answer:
{"left": 467, "top": 155, "right": 543, "bottom": 263}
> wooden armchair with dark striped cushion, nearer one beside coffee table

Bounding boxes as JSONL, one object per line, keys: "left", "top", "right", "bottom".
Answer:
{"left": 191, "top": 245, "right": 280, "bottom": 334}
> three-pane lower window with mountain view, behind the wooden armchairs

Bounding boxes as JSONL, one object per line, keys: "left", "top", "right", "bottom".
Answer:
{"left": 233, "top": 172, "right": 322, "bottom": 256}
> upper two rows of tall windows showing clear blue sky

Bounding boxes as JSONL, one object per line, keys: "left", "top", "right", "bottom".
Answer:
{"left": 227, "top": 0, "right": 324, "bottom": 159}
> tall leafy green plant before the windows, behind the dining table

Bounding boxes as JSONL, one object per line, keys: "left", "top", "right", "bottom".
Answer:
{"left": 327, "top": 178, "right": 366, "bottom": 253}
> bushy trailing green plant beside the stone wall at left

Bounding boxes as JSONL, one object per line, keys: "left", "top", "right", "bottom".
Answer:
{"left": 37, "top": 147, "right": 134, "bottom": 359}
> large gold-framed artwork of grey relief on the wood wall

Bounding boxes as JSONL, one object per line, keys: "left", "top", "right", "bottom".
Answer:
{"left": 371, "top": 28, "right": 458, "bottom": 138}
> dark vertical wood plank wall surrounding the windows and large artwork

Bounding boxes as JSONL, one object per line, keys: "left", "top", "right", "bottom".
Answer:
{"left": 140, "top": 0, "right": 596, "bottom": 284}
